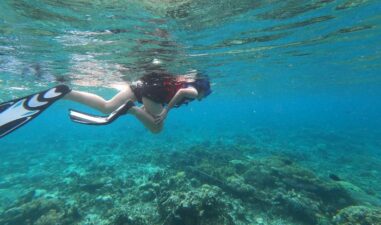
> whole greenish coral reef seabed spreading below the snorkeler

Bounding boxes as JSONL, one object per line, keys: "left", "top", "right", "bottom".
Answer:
{"left": 0, "top": 127, "right": 381, "bottom": 225}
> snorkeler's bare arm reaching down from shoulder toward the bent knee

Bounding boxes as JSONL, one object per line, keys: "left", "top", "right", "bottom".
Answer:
{"left": 155, "top": 87, "right": 198, "bottom": 123}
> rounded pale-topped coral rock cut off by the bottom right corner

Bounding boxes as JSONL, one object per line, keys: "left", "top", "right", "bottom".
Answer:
{"left": 333, "top": 206, "right": 381, "bottom": 225}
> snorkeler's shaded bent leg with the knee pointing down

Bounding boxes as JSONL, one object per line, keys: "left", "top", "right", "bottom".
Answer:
{"left": 128, "top": 97, "right": 163, "bottom": 133}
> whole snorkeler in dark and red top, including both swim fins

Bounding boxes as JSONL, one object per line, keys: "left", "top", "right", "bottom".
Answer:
{"left": 0, "top": 72, "right": 211, "bottom": 138}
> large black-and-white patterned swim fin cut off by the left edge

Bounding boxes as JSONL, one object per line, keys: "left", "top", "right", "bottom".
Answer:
{"left": 0, "top": 85, "right": 71, "bottom": 138}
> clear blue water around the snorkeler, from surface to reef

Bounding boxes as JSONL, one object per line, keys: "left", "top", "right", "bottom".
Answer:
{"left": 0, "top": 0, "right": 381, "bottom": 224}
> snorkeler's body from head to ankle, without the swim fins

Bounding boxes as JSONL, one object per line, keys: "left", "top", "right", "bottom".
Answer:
{"left": 65, "top": 72, "right": 211, "bottom": 133}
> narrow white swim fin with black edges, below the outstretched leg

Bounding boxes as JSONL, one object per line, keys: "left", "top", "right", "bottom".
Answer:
{"left": 69, "top": 101, "right": 135, "bottom": 125}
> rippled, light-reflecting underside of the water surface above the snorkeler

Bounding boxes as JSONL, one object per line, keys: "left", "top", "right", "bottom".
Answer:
{"left": 0, "top": 0, "right": 381, "bottom": 97}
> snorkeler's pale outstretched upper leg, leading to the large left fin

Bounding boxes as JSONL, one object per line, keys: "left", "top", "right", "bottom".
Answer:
{"left": 64, "top": 85, "right": 136, "bottom": 114}
